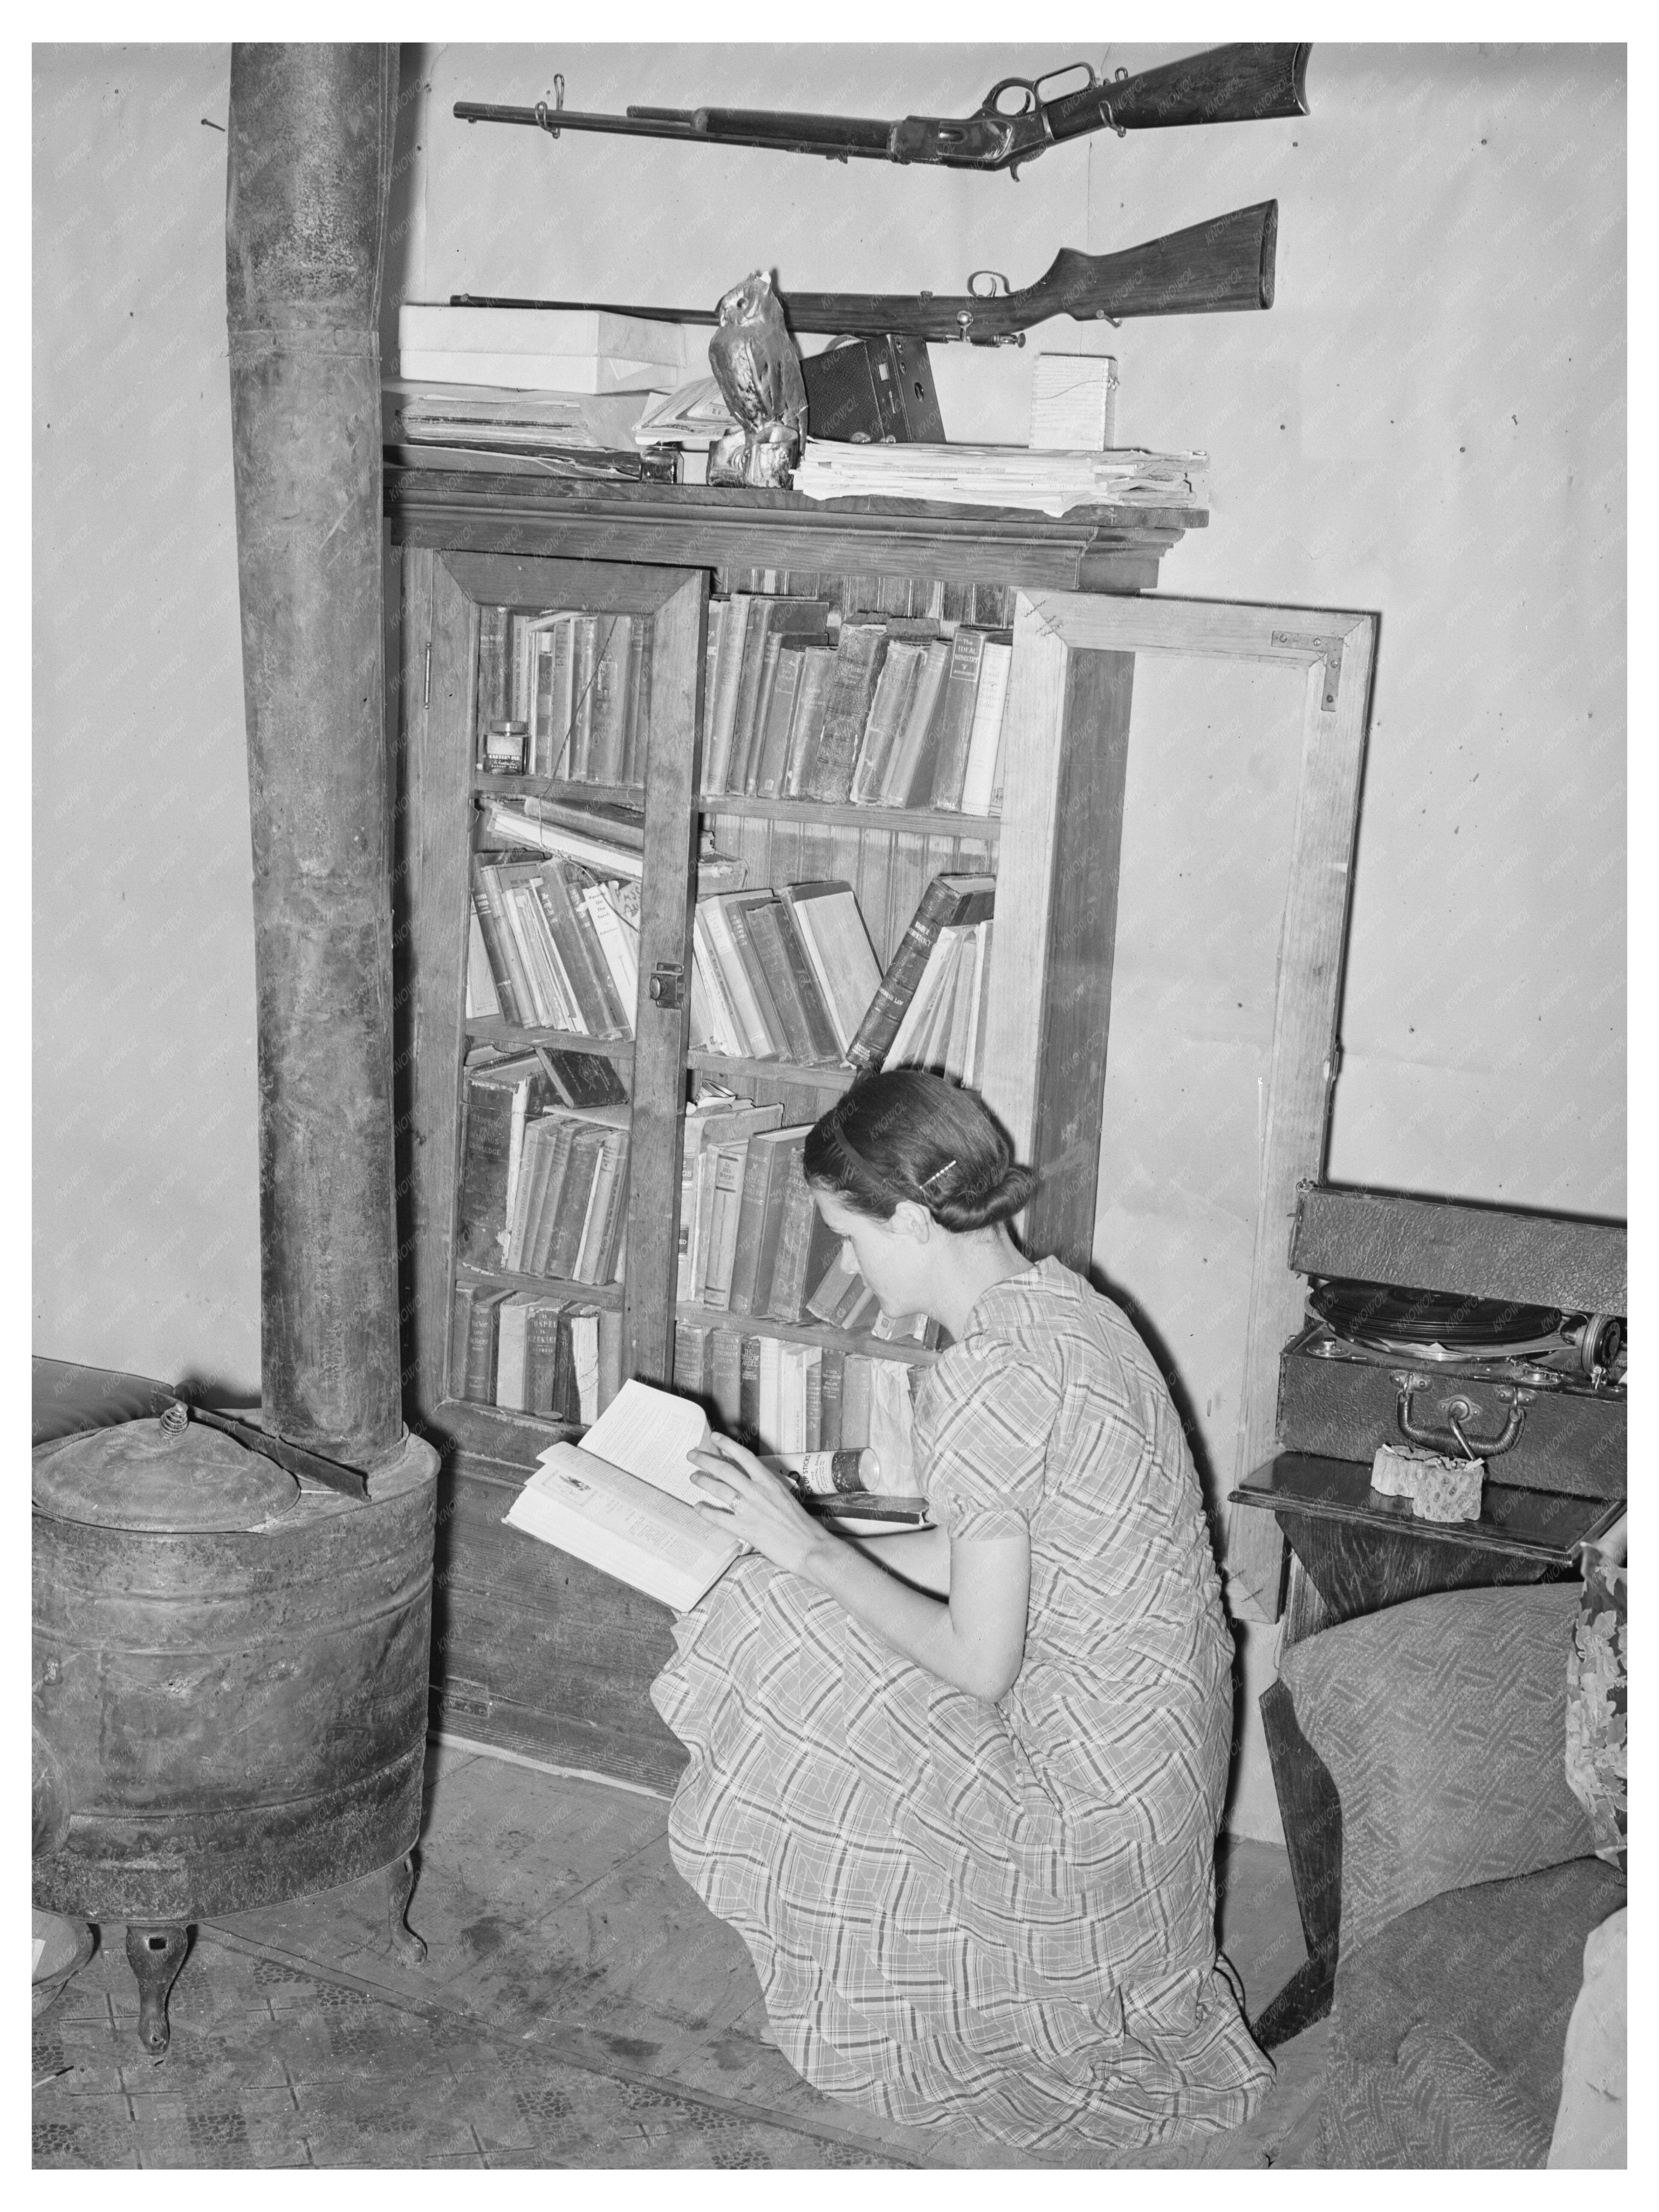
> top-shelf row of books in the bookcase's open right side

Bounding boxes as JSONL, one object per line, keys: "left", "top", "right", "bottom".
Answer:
{"left": 701, "top": 590, "right": 1013, "bottom": 814}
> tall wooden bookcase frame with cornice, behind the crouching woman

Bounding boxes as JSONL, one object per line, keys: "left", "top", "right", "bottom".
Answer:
{"left": 387, "top": 469, "right": 1206, "bottom": 1785}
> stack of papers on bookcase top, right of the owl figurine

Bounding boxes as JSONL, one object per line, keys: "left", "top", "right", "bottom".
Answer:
{"left": 794, "top": 438, "right": 1210, "bottom": 515}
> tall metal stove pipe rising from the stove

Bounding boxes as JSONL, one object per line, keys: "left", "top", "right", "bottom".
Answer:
{"left": 226, "top": 44, "right": 403, "bottom": 1469}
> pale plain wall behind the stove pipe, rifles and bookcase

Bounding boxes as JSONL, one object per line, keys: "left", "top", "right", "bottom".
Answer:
{"left": 33, "top": 44, "right": 1626, "bottom": 1834}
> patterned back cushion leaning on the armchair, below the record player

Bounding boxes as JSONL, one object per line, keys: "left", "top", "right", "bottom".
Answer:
{"left": 1278, "top": 1582, "right": 1595, "bottom": 1953}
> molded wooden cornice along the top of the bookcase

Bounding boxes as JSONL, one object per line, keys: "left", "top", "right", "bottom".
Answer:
{"left": 385, "top": 467, "right": 1210, "bottom": 593}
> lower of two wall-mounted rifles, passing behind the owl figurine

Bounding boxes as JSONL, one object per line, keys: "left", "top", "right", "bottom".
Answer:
{"left": 449, "top": 199, "right": 1278, "bottom": 345}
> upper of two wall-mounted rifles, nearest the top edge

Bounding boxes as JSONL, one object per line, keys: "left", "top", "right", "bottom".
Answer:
{"left": 456, "top": 44, "right": 1309, "bottom": 181}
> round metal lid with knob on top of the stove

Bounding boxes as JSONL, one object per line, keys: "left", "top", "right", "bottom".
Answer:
{"left": 33, "top": 1416, "right": 299, "bottom": 1535}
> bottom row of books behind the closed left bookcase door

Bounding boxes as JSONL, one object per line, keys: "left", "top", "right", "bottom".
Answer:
{"left": 449, "top": 1279, "right": 622, "bottom": 1427}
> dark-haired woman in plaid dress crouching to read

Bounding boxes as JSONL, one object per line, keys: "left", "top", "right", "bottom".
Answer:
{"left": 653, "top": 1068, "right": 1272, "bottom": 2150}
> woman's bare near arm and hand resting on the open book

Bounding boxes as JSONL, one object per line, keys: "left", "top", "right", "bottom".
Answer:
{"left": 690, "top": 1438, "right": 1031, "bottom": 1703}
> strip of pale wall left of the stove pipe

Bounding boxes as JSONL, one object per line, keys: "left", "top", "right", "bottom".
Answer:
{"left": 33, "top": 46, "right": 259, "bottom": 1396}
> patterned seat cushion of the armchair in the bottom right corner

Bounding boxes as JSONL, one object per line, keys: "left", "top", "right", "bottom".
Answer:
{"left": 1321, "top": 1858, "right": 1626, "bottom": 2168}
